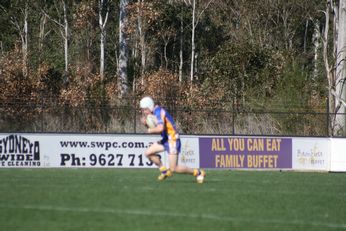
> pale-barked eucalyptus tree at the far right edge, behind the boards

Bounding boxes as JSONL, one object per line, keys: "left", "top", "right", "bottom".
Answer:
{"left": 323, "top": 0, "right": 346, "bottom": 135}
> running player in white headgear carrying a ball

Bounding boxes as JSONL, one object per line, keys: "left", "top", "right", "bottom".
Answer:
{"left": 140, "top": 96, "right": 206, "bottom": 183}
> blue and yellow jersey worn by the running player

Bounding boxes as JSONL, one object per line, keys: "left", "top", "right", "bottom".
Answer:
{"left": 153, "top": 106, "right": 179, "bottom": 141}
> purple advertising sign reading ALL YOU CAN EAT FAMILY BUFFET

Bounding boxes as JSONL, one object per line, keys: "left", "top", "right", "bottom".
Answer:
{"left": 199, "top": 137, "right": 292, "bottom": 169}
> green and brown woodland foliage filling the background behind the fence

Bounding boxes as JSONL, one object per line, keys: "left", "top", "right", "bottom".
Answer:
{"left": 0, "top": 0, "right": 333, "bottom": 133}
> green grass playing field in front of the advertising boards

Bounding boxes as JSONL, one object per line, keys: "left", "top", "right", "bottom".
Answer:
{"left": 0, "top": 169, "right": 346, "bottom": 231}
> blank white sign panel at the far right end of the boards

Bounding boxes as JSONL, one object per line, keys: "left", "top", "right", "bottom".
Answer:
{"left": 330, "top": 138, "right": 346, "bottom": 172}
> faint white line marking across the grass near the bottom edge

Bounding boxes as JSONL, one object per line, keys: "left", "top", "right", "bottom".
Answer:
{"left": 0, "top": 204, "right": 346, "bottom": 229}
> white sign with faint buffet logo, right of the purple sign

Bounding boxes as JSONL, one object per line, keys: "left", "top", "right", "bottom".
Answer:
{"left": 292, "top": 137, "right": 331, "bottom": 171}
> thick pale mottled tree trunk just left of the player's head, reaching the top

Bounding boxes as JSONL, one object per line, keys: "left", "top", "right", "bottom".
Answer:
{"left": 118, "top": 0, "right": 128, "bottom": 97}
